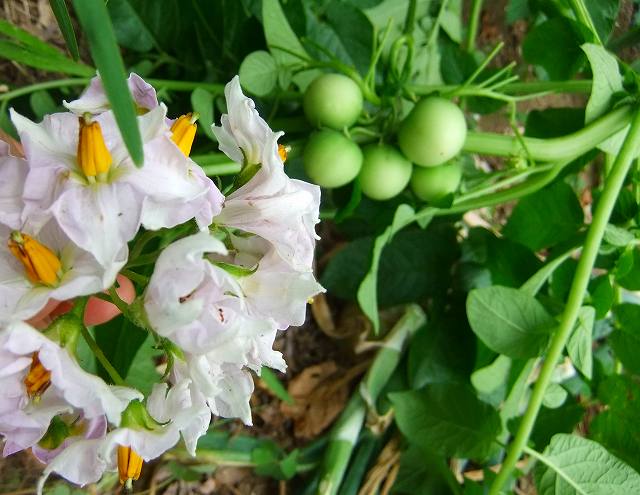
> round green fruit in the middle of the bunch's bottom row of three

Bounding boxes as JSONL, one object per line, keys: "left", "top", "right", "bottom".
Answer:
{"left": 360, "top": 144, "right": 413, "bottom": 200}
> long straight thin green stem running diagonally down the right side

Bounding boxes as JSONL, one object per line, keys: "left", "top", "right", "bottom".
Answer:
{"left": 489, "top": 111, "right": 640, "bottom": 495}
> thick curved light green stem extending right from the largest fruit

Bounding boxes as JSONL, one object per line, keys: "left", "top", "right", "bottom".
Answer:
{"left": 463, "top": 106, "right": 631, "bottom": 162}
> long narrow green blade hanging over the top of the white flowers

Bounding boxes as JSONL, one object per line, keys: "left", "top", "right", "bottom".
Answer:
{"left": 73, "top": 0, "right": 144, "bottom": 166}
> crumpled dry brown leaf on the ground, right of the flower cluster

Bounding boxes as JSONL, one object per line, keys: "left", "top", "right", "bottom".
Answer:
{"left": 280, "top": 361, "right": 349, "bottom": 438}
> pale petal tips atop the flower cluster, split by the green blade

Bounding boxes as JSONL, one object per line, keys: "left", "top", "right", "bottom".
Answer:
{"left": 64, "top": 73, "right": 158, "bottom": 115}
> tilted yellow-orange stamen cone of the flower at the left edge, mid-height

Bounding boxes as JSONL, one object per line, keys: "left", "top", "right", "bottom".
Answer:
{"left": 8, "top": 231, "right": 62, "bottom": 286}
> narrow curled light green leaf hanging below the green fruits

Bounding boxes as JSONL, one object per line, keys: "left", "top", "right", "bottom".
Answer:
{"left": 357, "top": 204, "right": 415, "bottom": 333}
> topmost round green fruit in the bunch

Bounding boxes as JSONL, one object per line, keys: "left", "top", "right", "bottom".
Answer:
{"left": 303, "top": 74, "right": 362, "bottom": 130}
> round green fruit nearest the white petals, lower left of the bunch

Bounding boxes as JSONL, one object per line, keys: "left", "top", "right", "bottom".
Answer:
{"left": 303, "top": 129, "right": 362, "bottom": 187}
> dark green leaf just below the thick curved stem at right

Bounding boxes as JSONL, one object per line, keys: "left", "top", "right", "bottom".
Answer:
{"left": 502, "top": 181, "right": 584, "bottom": 251}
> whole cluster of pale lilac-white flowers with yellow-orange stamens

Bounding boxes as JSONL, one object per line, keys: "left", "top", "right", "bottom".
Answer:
{"left": 0, "top": 74, "right": 323, "bottom": 490}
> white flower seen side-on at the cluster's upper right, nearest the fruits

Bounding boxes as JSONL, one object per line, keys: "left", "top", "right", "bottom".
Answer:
{"left": 213, "top": 77, "right": 320, "bottom": 270}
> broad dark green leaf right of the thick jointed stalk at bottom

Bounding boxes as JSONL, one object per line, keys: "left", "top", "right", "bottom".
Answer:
{"left": 390, "top": 384, "right": 501, "bottom": 459}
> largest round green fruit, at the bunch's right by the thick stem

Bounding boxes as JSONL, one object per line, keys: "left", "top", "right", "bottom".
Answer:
{"left": 398, "top": 96, "right": 467, "bottom": 167}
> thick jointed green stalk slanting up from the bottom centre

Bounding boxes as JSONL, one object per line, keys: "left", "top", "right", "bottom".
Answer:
{"left": 317, "top": 305, "right": 426, "bottom": 495}
